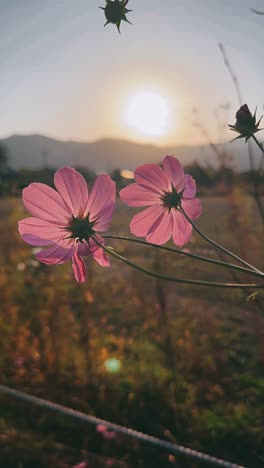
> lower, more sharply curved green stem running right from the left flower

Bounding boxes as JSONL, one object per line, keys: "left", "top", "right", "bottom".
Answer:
{"left": 92, "top": 236, "right": 264, "bottom": 289}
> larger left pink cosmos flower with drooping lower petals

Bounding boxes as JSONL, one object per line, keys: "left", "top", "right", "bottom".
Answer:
{"left": 18, "top": 167, "right": 115, "bottom": 283}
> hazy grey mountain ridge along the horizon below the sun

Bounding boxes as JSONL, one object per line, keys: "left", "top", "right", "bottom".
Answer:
{"left": 1, "top": 134, "right": 254, "bottom": 172}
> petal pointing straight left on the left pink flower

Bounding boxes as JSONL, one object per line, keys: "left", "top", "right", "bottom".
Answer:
{"left": 18, "top": 218, "right": 66, "bottom": 247}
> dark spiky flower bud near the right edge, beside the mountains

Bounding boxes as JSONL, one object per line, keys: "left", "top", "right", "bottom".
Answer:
{"left": 228, "top": 104, "right": 263, "bottom": 142}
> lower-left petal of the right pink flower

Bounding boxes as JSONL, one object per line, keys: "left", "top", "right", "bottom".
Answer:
{"left": 130, "top": 205, "right": 163, "bottom": 237}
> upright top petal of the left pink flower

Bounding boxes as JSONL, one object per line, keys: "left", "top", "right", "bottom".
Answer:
{"left": 54, "top": 167, "right": 88, "bottom": 216}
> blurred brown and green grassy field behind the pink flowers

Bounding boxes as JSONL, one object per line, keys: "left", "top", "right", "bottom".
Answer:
{"left": 0, "top": 189, "right": 264, "bottom": 468}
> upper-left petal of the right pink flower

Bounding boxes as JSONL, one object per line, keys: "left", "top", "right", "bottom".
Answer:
{"left": 135, "top": 164, "right": 170, "bottom": 194}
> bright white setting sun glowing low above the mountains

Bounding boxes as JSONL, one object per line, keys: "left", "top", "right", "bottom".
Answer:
{"left": 126, "top": 91, "right": 169, "bottom": 137}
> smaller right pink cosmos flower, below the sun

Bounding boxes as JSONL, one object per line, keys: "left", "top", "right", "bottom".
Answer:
{"left": 120, "top": 156, "right": 202, "bottom": 247}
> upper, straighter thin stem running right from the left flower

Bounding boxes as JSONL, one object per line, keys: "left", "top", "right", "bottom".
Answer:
{"left": 102, "top": 234, "right": 264, "bottom": 278}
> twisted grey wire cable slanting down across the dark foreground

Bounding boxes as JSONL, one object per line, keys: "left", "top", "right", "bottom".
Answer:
{"left": 0, "top": 385, "right": 245, "bottom": 468}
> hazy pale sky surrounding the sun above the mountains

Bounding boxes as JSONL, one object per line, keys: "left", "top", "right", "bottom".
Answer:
{"left": 0, "top": 0, "right": 264, "bottom": 144}
